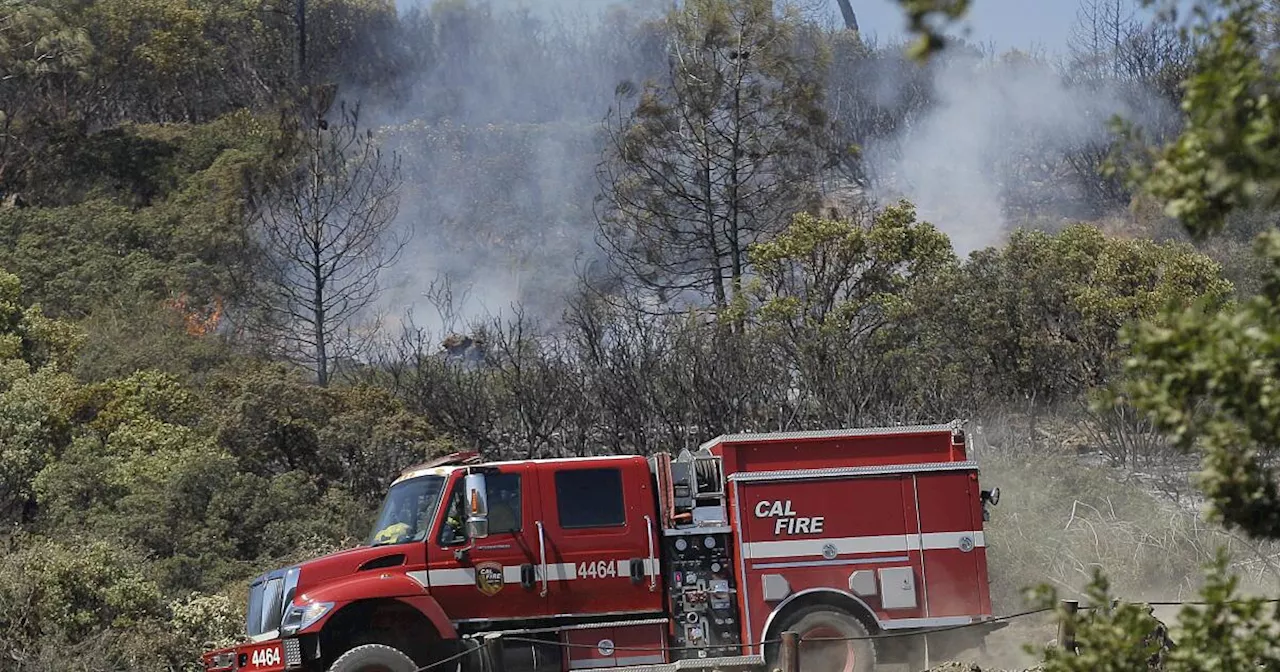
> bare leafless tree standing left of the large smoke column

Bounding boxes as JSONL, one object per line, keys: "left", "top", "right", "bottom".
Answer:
{"left": 245, "top": 99, "right": 407, "bottom": 385}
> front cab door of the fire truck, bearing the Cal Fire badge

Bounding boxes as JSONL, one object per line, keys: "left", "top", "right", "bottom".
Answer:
{"left": 426, "top": 465, "right": 548, "bottom": 621}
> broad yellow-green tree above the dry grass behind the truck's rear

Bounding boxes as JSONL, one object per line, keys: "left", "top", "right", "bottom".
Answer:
{"left": 962, "top": 224, "right": 1231, "bottom": 404}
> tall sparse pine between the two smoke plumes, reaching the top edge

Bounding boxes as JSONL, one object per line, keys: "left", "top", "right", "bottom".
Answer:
{"left": 598, "top": 0, "right": 828, "bottom": 307}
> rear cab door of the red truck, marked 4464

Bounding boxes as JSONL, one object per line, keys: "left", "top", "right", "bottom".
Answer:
{"left": 539, "top": 458, "right": 663, "bottom": 614}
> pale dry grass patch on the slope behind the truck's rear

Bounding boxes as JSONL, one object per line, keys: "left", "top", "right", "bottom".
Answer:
{"left": 977, "top": 419, "right": 1280, "bottom": 613}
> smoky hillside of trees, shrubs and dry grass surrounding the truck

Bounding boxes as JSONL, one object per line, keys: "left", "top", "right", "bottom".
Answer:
{"left": 0, "top": 0, "right": 1280, "bottom": 671}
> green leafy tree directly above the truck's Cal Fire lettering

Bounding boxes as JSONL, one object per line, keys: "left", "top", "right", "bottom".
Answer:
{"left": 750, "top": 202, "right": 957, "bottom": 426}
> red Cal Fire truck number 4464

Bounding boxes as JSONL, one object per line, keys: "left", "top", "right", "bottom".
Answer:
{"left": 204, "top": 422, "right": 1000, "bottom": 672}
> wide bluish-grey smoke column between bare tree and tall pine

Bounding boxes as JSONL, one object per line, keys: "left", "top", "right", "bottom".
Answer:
{"left": 353, "top": 0, "right": 662, "bottom": 335}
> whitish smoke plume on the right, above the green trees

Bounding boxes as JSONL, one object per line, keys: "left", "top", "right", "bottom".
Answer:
{"left": 867, "top": 46, "right": 1172, "bottom": 256}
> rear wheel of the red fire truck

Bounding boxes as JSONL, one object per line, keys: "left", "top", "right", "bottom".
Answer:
{"left": 769, "top": 605, "right": 876, "bottom": 672}
